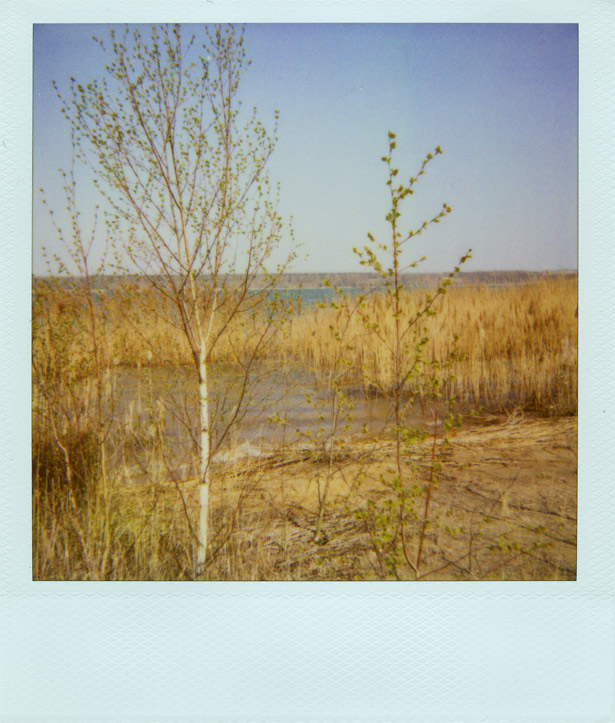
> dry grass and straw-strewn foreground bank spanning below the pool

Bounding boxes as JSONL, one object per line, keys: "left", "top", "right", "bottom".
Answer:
{"left": 34, "top": 416, "right": 576, "bottom": 580}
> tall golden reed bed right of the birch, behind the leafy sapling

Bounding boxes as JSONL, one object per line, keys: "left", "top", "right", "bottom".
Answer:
{"left": 284, "top": 277, "right": 577, "bottom": 415}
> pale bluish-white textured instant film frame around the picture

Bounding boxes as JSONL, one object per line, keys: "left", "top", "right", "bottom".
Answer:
{"left": 0, "top": 0, "right": 615, "bottom": 723}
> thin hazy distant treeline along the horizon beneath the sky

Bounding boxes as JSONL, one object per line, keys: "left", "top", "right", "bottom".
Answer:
{"left": 36, "top": 270, "right": 577, "bottom": 289}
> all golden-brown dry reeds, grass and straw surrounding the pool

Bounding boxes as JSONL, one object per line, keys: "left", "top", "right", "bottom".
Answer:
{"left": 33, "top": 278, "right": 577, "bottom": 580}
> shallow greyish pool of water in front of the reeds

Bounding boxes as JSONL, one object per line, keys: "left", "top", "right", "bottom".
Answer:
{"left": 113, "top": 364, "right": 428, "bottom": 477}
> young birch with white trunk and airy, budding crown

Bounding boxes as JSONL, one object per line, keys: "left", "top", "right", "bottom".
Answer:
{"left": 58, "top": 25, "right": 292, "bottom": 575}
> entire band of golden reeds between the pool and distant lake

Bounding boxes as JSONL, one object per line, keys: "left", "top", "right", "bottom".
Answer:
{"left": 33, "top": 276, "right": 578, "bottom": 415}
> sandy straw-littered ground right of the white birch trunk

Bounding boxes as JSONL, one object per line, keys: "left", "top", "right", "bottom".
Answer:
{"left": 206, "top": 414, "right": 577, "bottom": 580}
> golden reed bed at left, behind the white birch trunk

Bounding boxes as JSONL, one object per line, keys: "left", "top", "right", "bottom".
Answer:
{"left": 32, "top": 280, "right": 284, "bottom": 379}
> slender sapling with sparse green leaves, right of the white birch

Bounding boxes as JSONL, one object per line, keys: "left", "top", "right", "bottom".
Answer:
{"left": 354, "top": 131, "right": 471, "bottom": 579}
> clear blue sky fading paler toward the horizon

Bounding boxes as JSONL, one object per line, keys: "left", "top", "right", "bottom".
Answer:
{"left": 33, "top": 24, "right": 578, "bottom": 273}
